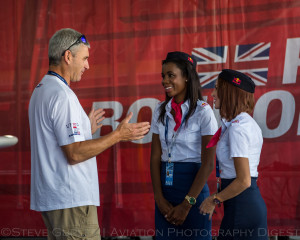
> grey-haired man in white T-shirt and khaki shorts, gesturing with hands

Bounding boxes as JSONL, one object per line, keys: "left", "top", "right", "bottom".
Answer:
{"left": 29, "top": 29, "right": 150, "bottom": 240}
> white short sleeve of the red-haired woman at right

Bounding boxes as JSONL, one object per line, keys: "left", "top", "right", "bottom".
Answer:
{"left": 229, "top": 123, "right": 250, "bottom": 158}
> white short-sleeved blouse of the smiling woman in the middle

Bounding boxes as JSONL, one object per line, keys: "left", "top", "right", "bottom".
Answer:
{"left": 150, "top": 99, "right": 218, "bottom": 162}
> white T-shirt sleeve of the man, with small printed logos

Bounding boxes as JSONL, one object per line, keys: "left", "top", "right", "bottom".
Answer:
{"left": 52, "top": 92, "right": 85, "bottom": 146}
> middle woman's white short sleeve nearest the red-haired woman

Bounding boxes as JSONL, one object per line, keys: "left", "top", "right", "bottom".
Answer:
{"left": 200, "top": 105, "right": 218, "bottom": 136}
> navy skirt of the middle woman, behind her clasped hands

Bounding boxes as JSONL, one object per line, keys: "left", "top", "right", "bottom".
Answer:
{"left": 155, "top": 162, "right": 212, "bottom": 240}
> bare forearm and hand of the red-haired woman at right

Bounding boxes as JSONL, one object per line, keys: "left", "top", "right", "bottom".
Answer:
{"left": 200, "top": 157, "right": 251, "bottom": 218}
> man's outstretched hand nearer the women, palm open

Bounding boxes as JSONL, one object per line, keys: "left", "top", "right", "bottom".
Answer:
{"left": 116, "top": 112, "right": 150, "bottom": 141}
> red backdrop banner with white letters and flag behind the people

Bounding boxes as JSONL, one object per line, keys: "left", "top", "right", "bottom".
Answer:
{"left": 0, "top": 0, "right": 300, "bottom": 237}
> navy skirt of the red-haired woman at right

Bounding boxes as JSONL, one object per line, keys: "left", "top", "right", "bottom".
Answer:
{"left": 218, "top": 178, "right": 268, "bottom": 240}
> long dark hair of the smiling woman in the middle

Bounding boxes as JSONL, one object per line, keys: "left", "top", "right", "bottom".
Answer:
{"left": 158, "top": 59, "right": 203, "bottom": 124}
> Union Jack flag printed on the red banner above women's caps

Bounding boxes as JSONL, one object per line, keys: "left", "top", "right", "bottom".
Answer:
{"left": 192, "top": 42, "right": 271, "bottom": 88}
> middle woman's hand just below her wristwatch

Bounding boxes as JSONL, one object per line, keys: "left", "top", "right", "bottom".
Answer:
{"left": 166, "top": 200, "right": 192, "bottom": 226}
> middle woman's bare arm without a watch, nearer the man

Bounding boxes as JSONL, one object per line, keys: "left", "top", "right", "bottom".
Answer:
{"left": 150, "top": 134, "right": 173, "bottom": 216}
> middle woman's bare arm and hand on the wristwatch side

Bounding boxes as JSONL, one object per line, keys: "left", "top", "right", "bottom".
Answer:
{"left": 167, "top": 135, "right": 215, "bottom": 225}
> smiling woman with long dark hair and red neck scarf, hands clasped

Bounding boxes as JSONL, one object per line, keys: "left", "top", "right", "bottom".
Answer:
{"left": 150, "top": 52, "right": 217, "bottom": 240}
